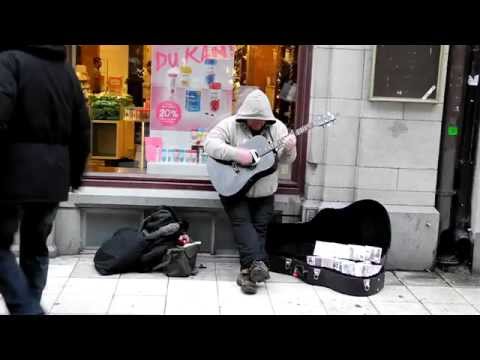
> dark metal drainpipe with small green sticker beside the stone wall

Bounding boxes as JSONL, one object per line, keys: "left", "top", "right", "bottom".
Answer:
{"left": 435, "top": 45, "right": 471, "bottom": 262}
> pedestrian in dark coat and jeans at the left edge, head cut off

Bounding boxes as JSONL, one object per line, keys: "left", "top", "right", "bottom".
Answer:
{"left": 0, "top": 45, "right": 90, "bottom": 314}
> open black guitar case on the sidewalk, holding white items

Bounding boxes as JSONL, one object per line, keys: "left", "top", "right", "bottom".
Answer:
{"left": 266, "top": 200, "right": 391, "bottom": 296}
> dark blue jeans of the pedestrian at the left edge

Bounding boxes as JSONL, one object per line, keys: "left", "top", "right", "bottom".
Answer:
{"left": 0, "top": 203, "right": 58, "bottom": 315}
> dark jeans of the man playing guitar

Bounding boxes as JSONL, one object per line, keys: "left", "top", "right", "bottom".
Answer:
{"left": 221, "top": 195, "right": 274, "bottom": 269}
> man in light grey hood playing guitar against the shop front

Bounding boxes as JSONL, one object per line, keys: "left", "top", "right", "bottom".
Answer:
{"left": 205, "top": 90, "right": 297, "bottom": 294}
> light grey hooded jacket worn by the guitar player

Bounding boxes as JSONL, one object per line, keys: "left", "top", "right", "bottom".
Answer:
{"left": 205, "top": 90, "right": 297, "bottom": 198}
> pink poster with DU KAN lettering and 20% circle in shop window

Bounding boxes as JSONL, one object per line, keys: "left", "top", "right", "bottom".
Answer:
{"left": 150, "top": 45, "right": 235, "bottom": 131}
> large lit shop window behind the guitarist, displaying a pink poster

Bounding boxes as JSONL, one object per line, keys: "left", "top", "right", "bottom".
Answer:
{"left": 72, "top": 45, "right": 299, "bottom": 180}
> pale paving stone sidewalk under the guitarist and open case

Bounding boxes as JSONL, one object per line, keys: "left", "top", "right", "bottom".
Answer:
{"left": 0, "top": 254, "right": 480, "bottom": 315}
